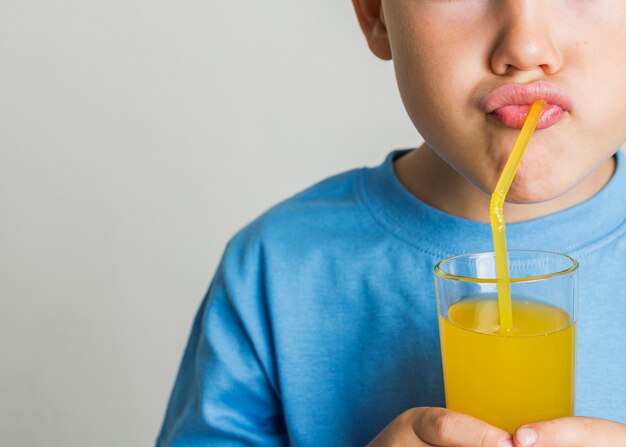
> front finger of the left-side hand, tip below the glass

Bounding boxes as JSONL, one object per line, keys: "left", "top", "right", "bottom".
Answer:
{"left": 413, "top": 408, "right": 513, "bottom": 447}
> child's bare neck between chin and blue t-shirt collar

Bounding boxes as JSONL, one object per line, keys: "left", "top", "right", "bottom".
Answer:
{"left": 394, "top": 144, "right": 615, "bottom": 223}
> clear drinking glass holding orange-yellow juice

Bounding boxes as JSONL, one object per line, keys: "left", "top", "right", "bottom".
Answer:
{"left": 435, "top": 250, "right": 578, "bottom": 432}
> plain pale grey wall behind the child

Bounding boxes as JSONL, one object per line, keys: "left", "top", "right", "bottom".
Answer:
{"left": 0, "top": 0, "right": 420, "bottom": 447}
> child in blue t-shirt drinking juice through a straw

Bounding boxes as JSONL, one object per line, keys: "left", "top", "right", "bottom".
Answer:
{"left": 158, "top": 0, "right": 626, "bottom": 447}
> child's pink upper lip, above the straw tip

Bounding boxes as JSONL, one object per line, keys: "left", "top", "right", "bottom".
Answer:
{"left": 483, "top": 81, "right": 572, "bottom": 113}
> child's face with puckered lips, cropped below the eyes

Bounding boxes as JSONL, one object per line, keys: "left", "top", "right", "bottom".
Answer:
{"left": 362, "top": 0, "right": 626, "bottom": 203}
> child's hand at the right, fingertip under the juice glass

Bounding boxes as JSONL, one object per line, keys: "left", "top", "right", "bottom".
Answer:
{"left": 514, "top": 417, "right": 626, "bottom": 447}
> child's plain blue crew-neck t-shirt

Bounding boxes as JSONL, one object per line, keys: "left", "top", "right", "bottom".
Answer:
{"left": 157, "top": 152, "right": 626, "bottom": 447}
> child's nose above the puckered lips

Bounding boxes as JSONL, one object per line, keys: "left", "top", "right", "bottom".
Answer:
{"left": 491, "top": 0, "right": 563, "bottom": 75}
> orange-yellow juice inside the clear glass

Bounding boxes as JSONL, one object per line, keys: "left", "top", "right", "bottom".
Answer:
{"left": 439, "top": 298, "right": 575, "bottom": 433}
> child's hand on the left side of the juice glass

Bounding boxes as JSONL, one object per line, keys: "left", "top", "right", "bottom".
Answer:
{"left": 367, "top": 407, "right": 513, "bottom": 447}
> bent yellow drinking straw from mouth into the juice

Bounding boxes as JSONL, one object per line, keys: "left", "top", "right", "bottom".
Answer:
{"left": 489, "top": 99, "right": 546, "bottom": 331}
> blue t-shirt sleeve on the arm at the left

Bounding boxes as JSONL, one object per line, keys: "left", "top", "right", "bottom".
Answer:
{"left": 157, "top": 240, "right": 288, "bottom": 447}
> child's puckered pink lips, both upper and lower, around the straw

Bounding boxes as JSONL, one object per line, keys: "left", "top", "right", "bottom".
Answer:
{"left": 483, "top": 81, "right": 572, "bottom": 129}
